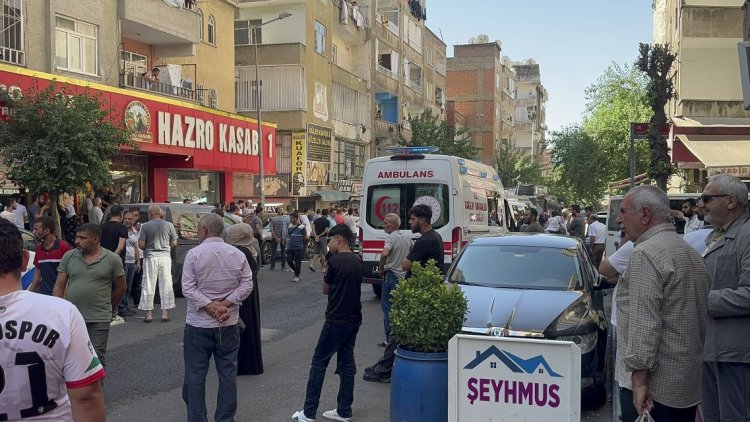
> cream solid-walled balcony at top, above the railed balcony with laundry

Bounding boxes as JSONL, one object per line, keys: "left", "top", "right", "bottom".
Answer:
{"left": 119, "top": 0, "right": 201, "bottom": 57}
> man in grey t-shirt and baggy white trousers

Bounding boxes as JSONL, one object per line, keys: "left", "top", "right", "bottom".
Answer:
{"left": 138, "top": 205, "right": 177, "bottom": 322}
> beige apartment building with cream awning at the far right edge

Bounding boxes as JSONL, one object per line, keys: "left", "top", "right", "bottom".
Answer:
{"left": 654, "top": 0, "right": 750, "bottom": 192}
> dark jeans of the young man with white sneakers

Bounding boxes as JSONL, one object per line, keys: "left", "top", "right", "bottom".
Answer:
{"left": 305, "top": 321, "right": 362, "bottom": 419}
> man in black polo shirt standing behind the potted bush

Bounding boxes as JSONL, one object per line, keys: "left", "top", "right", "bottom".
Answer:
{"left": 363, "top": 204, "right": 445, "bottom": 382}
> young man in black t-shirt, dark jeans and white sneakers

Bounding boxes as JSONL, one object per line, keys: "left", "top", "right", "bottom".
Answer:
{"left": 292, "top": 224, "right": 362, "bottom": 422}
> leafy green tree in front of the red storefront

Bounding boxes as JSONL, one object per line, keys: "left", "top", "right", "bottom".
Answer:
{"left": 0, "top": 83, "right": 135, "bottom": 236}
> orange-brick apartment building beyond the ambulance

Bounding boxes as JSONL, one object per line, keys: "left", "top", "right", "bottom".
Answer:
{"left": 446, "top": 35, "right": 516, "bottom": 166}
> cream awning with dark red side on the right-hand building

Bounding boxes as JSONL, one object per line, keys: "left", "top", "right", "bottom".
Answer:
{"left": 673, "top": 135, "right": 750, "bottom": 169}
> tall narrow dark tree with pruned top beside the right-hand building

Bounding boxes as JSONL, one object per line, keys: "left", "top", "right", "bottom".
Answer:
{"left": 636, "top": 43, "right": 675, "bottom": 191}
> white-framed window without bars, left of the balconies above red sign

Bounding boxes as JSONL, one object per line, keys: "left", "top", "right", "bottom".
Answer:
{"left": 55, "top": 16, "right": 99, "bottom": 75}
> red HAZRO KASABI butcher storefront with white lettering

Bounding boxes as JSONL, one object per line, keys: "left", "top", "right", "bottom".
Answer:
{"left": 0, "top": 65, "right": 276, "bottom": 204}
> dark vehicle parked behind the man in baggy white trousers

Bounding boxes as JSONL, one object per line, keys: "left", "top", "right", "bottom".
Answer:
{"left": 104, "top": 202, "right": 235, "bottom": 297}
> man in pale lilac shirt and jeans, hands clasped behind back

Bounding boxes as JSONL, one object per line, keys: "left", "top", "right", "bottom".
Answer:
{"left": 182, "top": 214, "right": 253, "bottom": 422}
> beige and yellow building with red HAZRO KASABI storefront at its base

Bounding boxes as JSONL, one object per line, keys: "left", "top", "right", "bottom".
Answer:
{"left": 0, "top": 0, "right": 275, "bottom": 203}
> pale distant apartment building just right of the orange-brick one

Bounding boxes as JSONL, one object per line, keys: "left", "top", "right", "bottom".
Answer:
{"left": 513, "top": 59, "right": 548, "bottom": 157}
